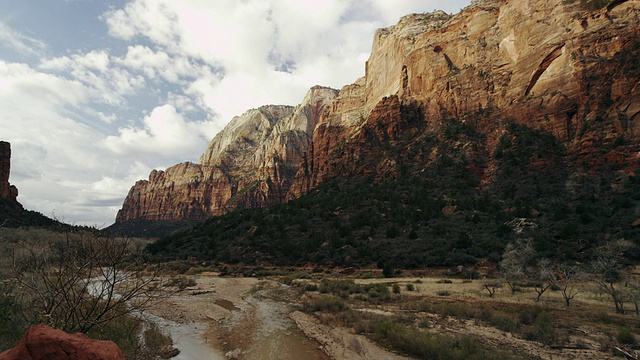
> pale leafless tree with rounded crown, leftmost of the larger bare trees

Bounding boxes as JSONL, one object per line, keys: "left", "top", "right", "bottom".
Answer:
{"left": 500, "top": 239, "right": 535, "bottom": 295}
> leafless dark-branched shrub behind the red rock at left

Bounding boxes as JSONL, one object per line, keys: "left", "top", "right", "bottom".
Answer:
{"left": 13, "top": 233, "right": 160, "bottom": 333}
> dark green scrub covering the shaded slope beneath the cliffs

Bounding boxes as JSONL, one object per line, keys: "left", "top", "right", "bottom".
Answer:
{"left": 148, "top": 121, "right": 640, "bottom": 269}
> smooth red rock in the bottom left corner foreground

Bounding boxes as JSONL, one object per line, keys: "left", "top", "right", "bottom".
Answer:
{"left": 0, "top": 324, "right": 124, "bottom": 360}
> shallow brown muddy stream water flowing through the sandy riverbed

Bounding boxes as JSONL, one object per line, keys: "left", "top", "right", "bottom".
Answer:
{"left": 149, "top": 281, "right": 330, "bottom": 360}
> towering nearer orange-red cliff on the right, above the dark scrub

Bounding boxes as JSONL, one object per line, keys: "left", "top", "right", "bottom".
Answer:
{"left": 289, "top": 0, "right": 640, "bottom": 198}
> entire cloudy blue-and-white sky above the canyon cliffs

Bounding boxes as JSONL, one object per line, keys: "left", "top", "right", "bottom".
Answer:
{"left": 0, "top": 0, "right": 471, "bottom": 228}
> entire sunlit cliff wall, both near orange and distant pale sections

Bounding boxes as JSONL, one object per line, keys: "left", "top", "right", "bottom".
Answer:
{"left": 116, "top": 0, "right": 640, "bottom": 221}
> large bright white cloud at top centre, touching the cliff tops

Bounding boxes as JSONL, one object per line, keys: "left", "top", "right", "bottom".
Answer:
{"left": 103, "top": 0, "right": 468, "bottom": 122}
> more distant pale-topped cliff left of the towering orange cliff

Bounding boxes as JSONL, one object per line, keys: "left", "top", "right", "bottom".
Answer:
{"left": 116, "top": 87, "right": 337, "bottom": 222}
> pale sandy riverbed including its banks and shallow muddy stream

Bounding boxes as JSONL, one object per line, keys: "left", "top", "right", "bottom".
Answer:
{"left": 149, "top": 273, "right": 402, "bottom": 360}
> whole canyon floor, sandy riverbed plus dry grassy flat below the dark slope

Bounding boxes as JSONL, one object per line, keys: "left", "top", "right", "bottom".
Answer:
{"left": 145, "top": 269, "right": 638, "bottom": 360}
